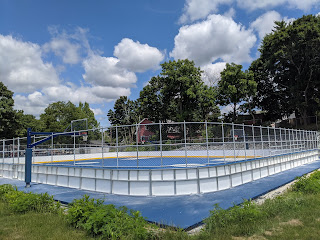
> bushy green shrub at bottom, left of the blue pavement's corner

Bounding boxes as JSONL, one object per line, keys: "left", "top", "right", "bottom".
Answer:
{"left": 67, "top": 195, "right": 152, "bottom": 239}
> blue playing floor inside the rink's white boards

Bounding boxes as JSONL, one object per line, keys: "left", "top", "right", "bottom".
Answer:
{"left": 37, "top": 157, "right": 243, "bottom": 169}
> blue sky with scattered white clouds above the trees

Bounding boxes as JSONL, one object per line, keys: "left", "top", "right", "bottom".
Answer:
{"left": 0, "top": 0, "right": 320, "bottom": 126}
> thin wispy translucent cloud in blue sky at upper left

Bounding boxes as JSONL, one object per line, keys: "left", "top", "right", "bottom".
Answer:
{"left": 43, "top": 38, "right": 81, "bottom": 64}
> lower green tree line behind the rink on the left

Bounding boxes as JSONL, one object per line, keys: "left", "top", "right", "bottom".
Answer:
{"left": 0, "top": 82, "right": 99, "bottom": 139}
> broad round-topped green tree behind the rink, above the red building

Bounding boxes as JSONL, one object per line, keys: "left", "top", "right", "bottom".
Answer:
{"left": 138, "top": 59, "right": 220, "bottom": 122}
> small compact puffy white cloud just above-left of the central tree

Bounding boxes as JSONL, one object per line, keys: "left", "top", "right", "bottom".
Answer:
{"left": 113, "top": 38, "right": 164, "bottom": 72}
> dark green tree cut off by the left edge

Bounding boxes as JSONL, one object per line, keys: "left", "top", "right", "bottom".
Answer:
{"left": 0, "top": 82, "right": 18, "bottom": 138}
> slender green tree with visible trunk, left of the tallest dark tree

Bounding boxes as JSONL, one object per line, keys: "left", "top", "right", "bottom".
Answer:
{"left": 217, "top": 63, "right": 257, "bottom": 122}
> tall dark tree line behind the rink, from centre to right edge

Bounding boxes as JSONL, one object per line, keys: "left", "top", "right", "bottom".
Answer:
{"left": 108, "top": 15, "right": 320, "bottom": 129}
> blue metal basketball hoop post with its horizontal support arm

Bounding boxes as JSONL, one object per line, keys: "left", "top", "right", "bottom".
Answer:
{"left": 25, "top": 128, "right": 80, "bottom": 187}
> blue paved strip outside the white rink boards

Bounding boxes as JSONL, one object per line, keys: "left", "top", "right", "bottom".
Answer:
{"left": 0, "top": 160, "right": 320, "bottom": 229}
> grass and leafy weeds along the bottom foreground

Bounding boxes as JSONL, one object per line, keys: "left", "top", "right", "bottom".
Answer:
{"left": 0, "top": 171, "right": 320, "bottom": 240}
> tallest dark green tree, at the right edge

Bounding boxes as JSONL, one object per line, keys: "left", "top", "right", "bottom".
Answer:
{"left": 250, "top": 15, "right": 320, "bottom": 125}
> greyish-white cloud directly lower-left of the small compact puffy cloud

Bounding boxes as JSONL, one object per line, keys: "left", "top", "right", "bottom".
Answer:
{"left": 83, "top": 55, "right": 137, "bottom": 88}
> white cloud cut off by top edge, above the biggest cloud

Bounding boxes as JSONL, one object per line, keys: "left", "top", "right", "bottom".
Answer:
{"left": 179, "top": 0, "right": 233, "bottom": 23}
